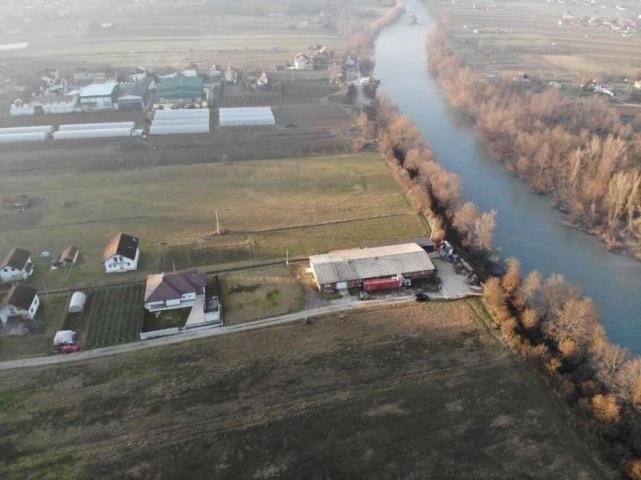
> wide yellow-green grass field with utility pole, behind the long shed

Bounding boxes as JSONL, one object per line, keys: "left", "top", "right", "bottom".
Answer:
{"left": 0, "top": 154, "right": 424, "bottom": 289}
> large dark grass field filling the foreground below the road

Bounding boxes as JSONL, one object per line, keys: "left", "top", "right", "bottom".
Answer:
{"left": 0, "top": 302, "right": 607, "bottom": 480}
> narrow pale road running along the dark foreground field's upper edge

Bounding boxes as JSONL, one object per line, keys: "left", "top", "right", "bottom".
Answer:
{"left": 0, "top": 296, "right": 414, "bottom": 371}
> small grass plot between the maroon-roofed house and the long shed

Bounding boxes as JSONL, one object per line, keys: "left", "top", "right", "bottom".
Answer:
{"left": 221, "top": 264, "right": 304, "bottom": 325}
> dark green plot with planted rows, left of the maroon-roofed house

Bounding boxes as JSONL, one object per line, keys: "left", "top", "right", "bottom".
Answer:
{"left": 65, "top": 284, "right": 145, "bottom": 349}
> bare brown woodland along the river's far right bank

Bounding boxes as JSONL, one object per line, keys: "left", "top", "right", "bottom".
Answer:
{"left": 428, "top": 23, "right": 641, "bottom": 253}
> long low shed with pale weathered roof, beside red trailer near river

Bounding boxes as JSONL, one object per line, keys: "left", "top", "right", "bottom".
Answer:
{"left": 309, "top": 243, "right": 435, "bottom": 290}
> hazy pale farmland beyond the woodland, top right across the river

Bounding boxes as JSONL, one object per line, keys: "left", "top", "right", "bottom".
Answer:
{"left": 428, "top": 0, "right": 641, "bottom": 83}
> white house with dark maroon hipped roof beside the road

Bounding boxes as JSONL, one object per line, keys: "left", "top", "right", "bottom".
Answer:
{"left": 145, "top": 270, "right": 207, "bottom": 312}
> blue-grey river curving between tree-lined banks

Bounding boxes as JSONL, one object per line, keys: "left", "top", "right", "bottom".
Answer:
{"left": 375, "top": 0, "right": 641, "bottom": 354}
